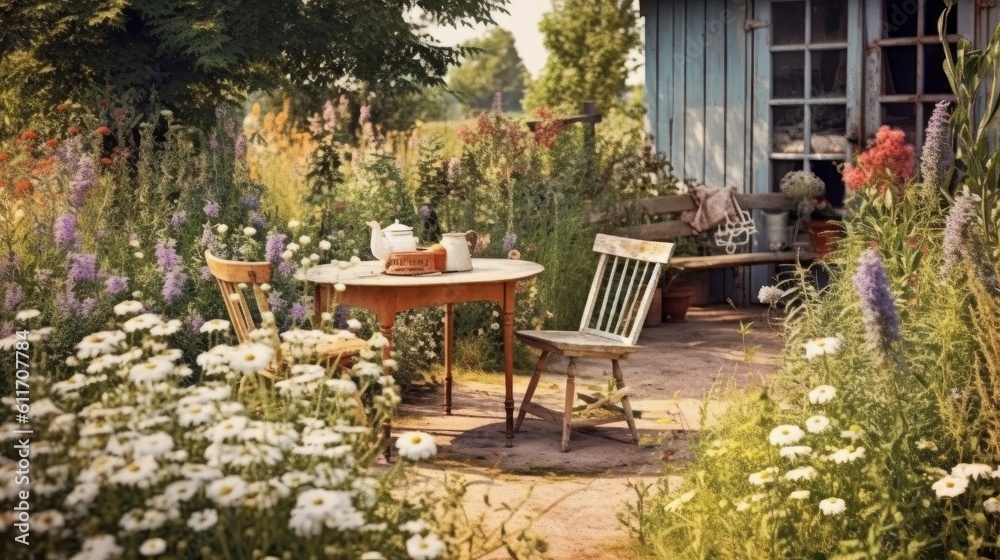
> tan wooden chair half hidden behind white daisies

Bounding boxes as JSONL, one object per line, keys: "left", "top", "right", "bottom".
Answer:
{"left": 205, "top": 251, "right": 367, "bottom": 375}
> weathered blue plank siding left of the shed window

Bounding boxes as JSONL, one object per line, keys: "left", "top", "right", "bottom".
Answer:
{"left": 640, "top": 0, "right": 751, "bottom": 192}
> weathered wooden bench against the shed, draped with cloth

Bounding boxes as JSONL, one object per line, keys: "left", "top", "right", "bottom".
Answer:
{"left": 591, "top": 193, "right": 820, "bottom": 302}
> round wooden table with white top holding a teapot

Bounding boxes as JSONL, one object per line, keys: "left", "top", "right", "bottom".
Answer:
{"left": 305, "top": 259, "right": 545, "bottom": 447}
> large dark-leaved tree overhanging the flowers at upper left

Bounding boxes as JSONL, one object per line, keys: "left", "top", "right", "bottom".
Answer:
{"left": 0, "top": 0, "right": 506, "bottom": 130}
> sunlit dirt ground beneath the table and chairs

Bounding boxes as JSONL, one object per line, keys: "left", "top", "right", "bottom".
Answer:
{"left": 393, "top": 305, "right": 782, "bottom": 560}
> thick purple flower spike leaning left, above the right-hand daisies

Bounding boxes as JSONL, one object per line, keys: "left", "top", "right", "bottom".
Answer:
{"left": 854, "top": 249, "right": 902, "bottom": 354}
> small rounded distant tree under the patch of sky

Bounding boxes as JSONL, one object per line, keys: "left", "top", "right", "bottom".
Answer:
{"left": 448, "top": 27, "right": 528, "bottom": 111}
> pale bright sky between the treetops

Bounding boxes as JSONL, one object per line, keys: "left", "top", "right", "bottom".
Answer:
{"left": 429, "top": 0, "right": 552, "bottom": 78}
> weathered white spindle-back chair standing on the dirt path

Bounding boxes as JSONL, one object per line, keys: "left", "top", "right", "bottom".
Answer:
{"left": 514, "top": 234, "right": 674, "bottom": 452}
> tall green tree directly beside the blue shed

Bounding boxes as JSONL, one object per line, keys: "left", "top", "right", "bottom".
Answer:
{"left": 524, "top": 0, "right": 642, "bottom": 111}
